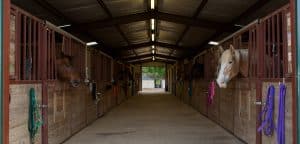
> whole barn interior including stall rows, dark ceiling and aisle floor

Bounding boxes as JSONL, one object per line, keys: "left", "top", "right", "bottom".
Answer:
{"left": 9, "top": 0, "right": 295, "bottom": 144}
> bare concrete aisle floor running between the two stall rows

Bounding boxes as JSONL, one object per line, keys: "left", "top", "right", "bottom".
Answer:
{"left": 65, "top": 93, "right": 242, "bottom": 144}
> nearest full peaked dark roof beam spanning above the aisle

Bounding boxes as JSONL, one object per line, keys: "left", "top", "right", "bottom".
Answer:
{"left": 71, "top": 10, "right": 231, "bottom": 30}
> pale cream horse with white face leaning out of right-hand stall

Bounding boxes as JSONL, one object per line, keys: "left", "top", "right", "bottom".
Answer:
{"left": 216, "top": 45, "right": 249, "bottom": 88}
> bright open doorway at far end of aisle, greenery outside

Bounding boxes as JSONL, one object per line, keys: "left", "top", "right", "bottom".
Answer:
{"left": 142, "top": 66, "right": 166, "bottom": 92}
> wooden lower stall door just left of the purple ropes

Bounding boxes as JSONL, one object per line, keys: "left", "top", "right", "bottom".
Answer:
{"left": 233, "top": 78, "right": 257, "bottom": 143}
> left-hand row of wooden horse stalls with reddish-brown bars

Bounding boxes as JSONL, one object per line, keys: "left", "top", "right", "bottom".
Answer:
{"left": 9, "top": 5, "right": 128, "bottom": 144}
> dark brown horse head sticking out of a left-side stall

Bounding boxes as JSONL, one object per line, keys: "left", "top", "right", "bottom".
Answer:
{"left": 56, "top": 53, "right": 80, "bottom": 87}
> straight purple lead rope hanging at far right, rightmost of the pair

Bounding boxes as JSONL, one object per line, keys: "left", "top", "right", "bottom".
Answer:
{"left": 277, "top": 83, "right": 286, "bottom": 144}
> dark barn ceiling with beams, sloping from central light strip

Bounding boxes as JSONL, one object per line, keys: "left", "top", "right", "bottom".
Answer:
{"left": 12, "top": 0, "right": 288, "bottom": 63}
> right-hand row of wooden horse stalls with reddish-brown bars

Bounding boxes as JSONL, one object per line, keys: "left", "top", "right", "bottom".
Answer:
{"left": 176, "top": 5, "right": 295, "bottom": 143}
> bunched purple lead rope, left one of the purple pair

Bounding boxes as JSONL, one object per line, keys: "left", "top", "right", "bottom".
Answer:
{"left": 257, "top": 85, "right": 275, "bottom": 136}
